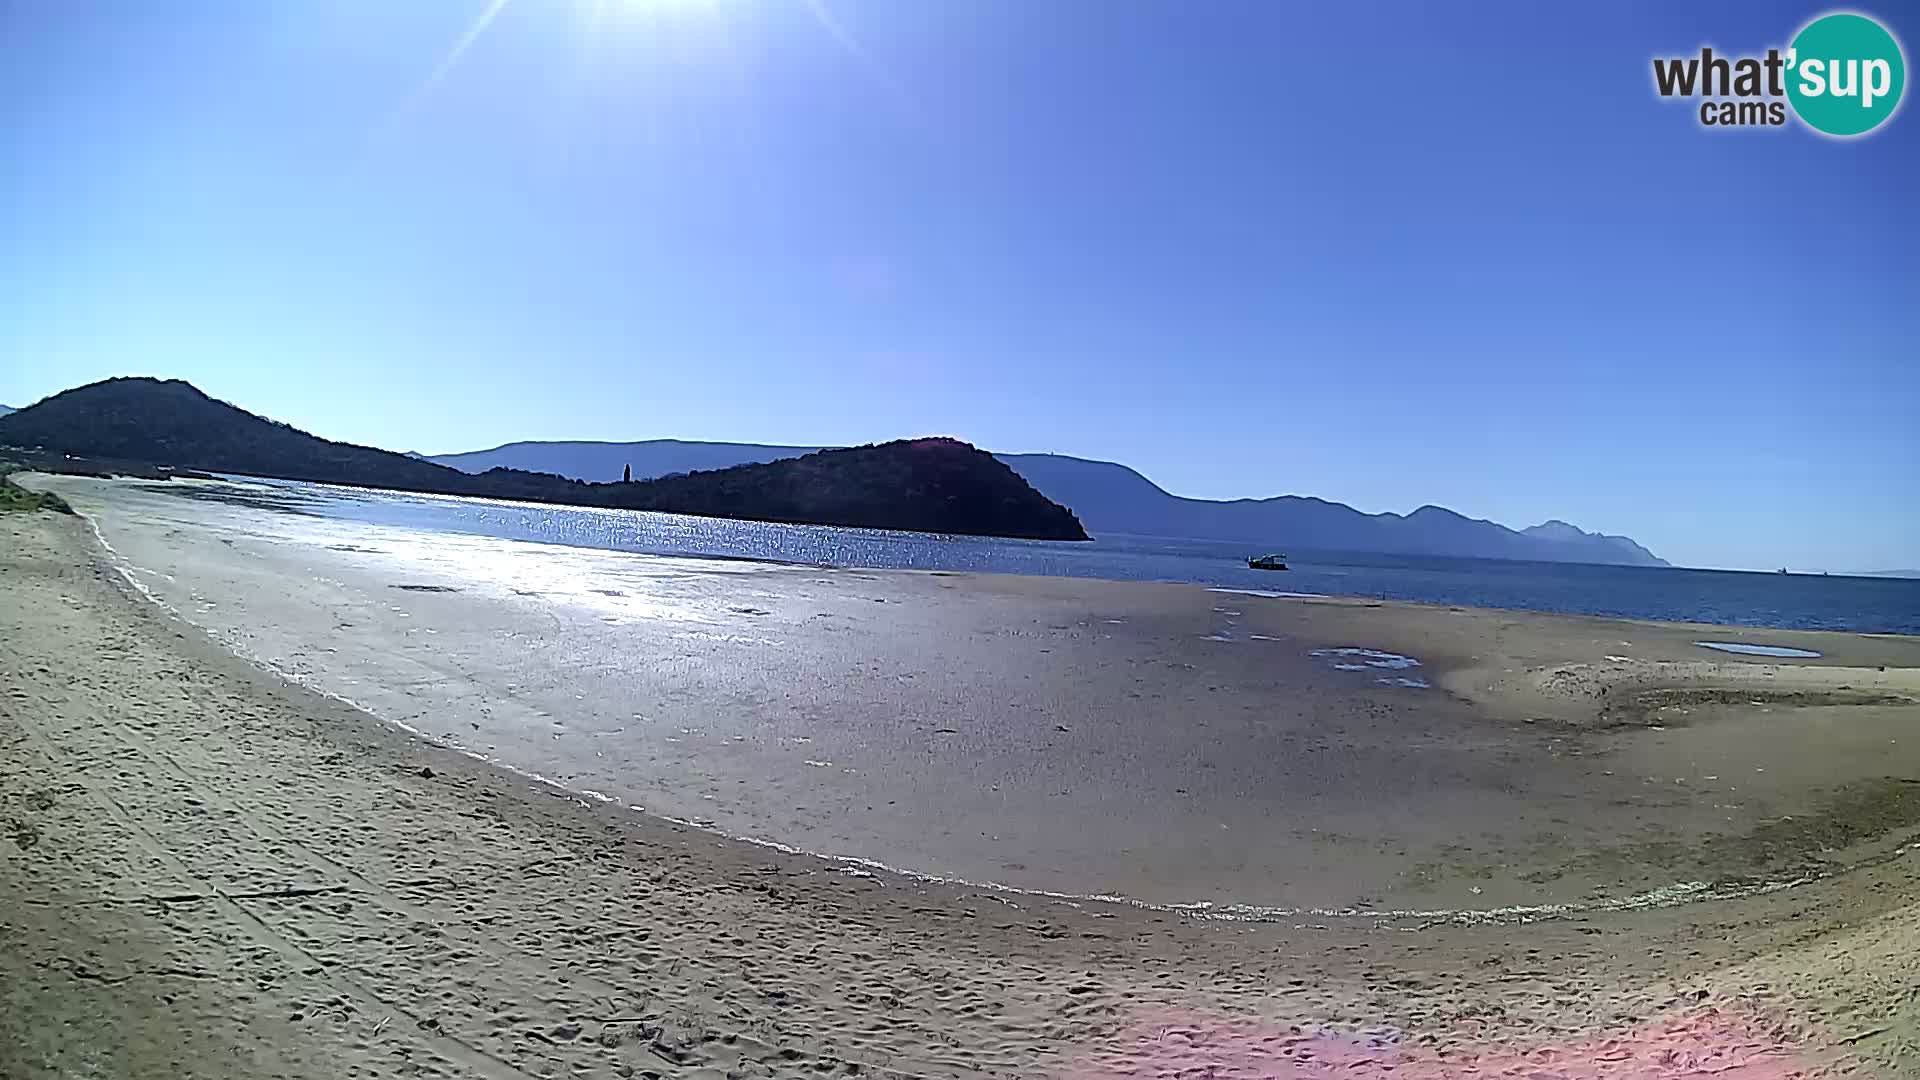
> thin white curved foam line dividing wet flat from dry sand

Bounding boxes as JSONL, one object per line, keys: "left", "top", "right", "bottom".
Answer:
{"left": 81, "top": 513, "right": 1920, "bottom": 932}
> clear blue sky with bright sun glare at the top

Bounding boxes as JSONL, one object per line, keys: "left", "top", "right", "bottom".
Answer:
{"left": 0, "top": 0, "right": 1920, "bottom": 569}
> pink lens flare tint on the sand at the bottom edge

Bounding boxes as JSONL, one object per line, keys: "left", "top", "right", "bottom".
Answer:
{"left": 1060, "top": 1009, "right": 1859, "bottom": 1080}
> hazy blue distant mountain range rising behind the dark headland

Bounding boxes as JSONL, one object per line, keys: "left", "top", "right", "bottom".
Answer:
{"left": 424, "top": 438, "right": 1668, "bottom": 567}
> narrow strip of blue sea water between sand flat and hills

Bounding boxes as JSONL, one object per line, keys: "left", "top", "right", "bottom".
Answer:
{"left": 191, "top": 477, "right": 1920, "bottom": 634}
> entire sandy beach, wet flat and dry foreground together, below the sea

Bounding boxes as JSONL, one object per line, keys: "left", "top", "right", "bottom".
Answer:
{"left": 0, "top": 480, "right": 1920, "bottom": 1080}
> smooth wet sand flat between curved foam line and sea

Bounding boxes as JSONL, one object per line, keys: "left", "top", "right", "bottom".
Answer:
{"left": 22, "top": 468, "right": 1920, "bottom": 911}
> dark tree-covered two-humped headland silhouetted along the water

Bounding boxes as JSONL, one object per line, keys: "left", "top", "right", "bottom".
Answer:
{"left": 0, "top": 379, "right": 1087, "bottom": 540}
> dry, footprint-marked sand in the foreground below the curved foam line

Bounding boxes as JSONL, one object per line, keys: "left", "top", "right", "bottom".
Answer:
{"left": 0, "top": 503, "right": 1916, "bottom": 1076}
